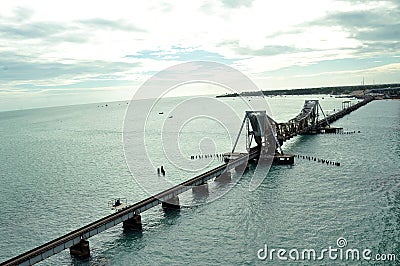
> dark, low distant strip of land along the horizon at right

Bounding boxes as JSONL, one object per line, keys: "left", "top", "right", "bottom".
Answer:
{"left": 217, "top": 83, "right": 400, "bottom": 98}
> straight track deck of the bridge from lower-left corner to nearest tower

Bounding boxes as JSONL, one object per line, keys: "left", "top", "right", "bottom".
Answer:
{"left": 0, "top": 150, "right": 259, "bottom": 266}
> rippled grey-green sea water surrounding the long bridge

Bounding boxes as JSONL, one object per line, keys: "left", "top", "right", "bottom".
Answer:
{"left": 0, "top": 96, "right": 400, "bottom": 265}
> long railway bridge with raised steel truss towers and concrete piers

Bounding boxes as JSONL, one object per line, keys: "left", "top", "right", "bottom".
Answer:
{"left": 0, "top": 97, "right": 373, "bottom": 266}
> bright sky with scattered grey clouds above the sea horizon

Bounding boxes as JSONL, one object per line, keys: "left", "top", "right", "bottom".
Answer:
{"left": 0, "top": 0, "right": 400, "bottom": 110}
